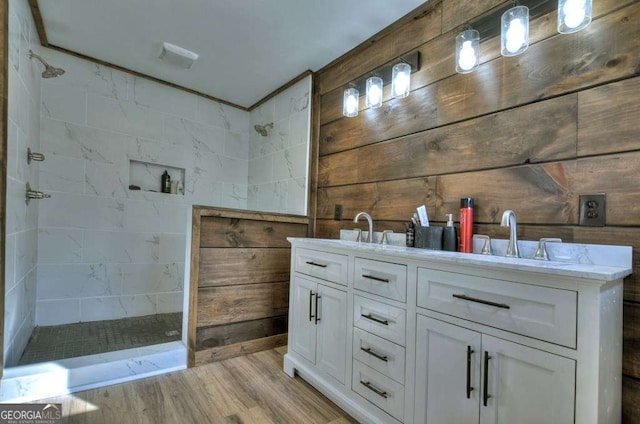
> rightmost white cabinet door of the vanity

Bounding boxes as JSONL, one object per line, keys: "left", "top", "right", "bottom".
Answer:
{"left": 480, "top": 335, "right": 575, "bottom": 424}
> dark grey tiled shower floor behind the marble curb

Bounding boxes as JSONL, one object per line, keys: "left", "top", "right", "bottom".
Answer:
{"left": 18, "top": 312, "right": 182, "bottom": 365}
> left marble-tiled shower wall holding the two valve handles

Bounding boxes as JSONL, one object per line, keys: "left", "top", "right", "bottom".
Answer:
{"left": 4, "top": 0, "right": 43, "bottom": 366}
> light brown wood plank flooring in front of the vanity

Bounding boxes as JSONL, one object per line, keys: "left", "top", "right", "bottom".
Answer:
{"left": 39, "top": 346, "right": 356, "bottom": 424}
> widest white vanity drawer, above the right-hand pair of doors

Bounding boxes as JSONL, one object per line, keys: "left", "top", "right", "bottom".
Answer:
{"left": 417, "top": 268, "right": 578, "bottom": 348}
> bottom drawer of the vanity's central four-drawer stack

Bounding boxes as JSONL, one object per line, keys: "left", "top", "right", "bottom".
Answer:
{"left": 351, "top": 360, "right": 404, "bottom": 421}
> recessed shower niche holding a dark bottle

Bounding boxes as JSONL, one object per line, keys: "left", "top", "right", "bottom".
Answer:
{"left": 129, "top": 160, "right": 185, "bottom": 196}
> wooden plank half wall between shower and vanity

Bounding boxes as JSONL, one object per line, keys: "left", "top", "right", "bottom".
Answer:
{"left": 188, "top": 206, "right": 309, "bottom": 367}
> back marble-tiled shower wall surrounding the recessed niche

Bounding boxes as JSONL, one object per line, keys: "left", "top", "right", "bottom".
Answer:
{"left": 36, "top": 49, "right": 250, "bottom": 325}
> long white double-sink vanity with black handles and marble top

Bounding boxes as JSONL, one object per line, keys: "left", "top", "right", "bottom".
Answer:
{"left": 284, "top": 238, "right": 632, "bottom": 424}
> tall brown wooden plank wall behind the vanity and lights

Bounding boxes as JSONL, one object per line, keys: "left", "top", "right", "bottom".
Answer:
{"left": 312, "top": 0, "right": 640, "bottom": 423}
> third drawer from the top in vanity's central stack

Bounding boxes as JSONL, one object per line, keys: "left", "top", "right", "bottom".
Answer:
{"left": 353, "top": 328, "right": 404, "bottom": 384}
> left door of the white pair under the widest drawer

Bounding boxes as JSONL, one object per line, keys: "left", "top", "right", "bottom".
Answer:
{"left": 415, "top": 315, "right": 480, "bottom": 424}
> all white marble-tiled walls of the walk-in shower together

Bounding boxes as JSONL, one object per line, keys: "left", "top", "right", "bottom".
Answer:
{"left": 5, "top": 0, "right": 311, "bottom": 366}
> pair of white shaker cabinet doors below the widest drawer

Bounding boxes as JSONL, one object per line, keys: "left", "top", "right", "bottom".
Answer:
{"left": 415, "top": 315, "right": 575, "bottom": 424}
